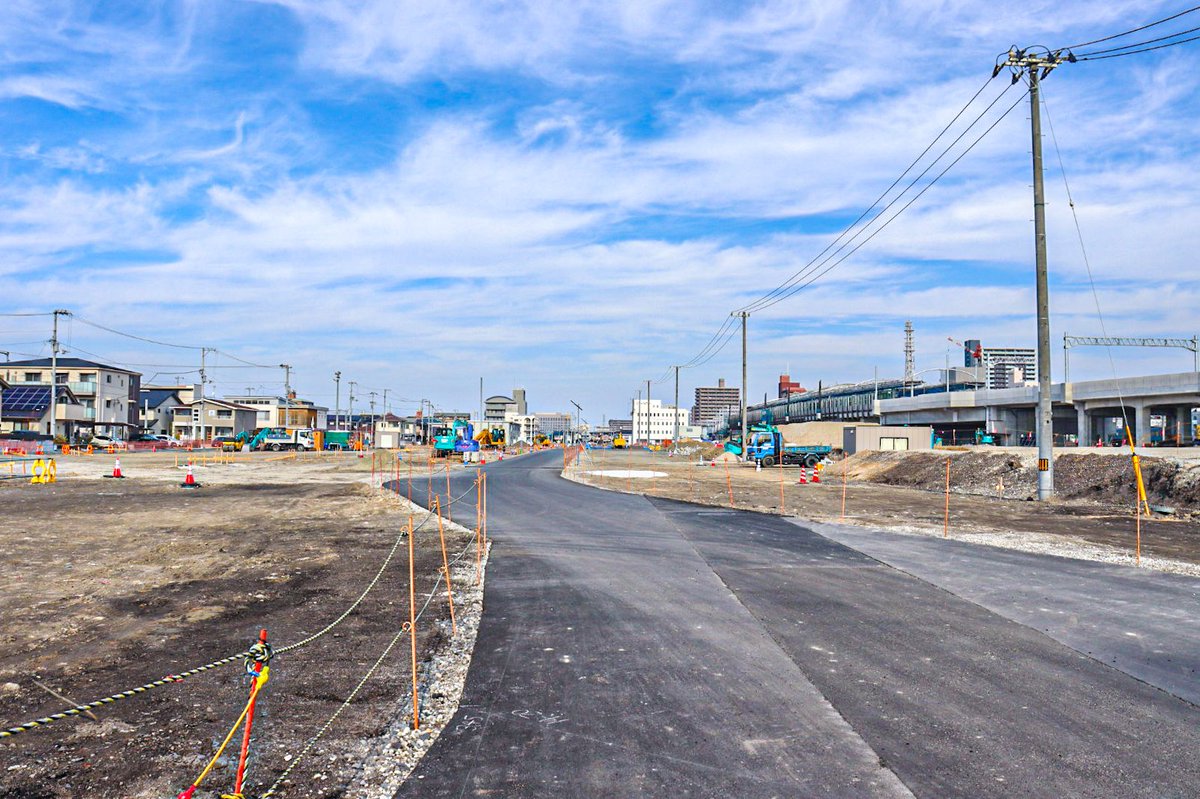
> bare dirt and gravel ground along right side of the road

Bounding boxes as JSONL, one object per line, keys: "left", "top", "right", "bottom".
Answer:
{"left": 568, "top": 446, "right": 1200, "bottom": 575}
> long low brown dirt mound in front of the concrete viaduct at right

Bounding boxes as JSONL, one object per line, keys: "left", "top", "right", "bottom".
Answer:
{"left": 830, "top": 450, "right": 1200, "bottom": 512}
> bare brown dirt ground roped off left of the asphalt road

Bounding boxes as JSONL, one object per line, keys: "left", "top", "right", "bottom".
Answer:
{"left": 0, "top": 451, "right": 480, "bottom": 799}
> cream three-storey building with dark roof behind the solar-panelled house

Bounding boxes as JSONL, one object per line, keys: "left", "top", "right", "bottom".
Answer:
{"left": 0, "top": 358, "right": 142, "bottom": 439}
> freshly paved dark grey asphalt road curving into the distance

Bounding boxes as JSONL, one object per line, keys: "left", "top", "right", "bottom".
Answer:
{"left": 397, "top": 451, "right": 1200, "bottom": 798}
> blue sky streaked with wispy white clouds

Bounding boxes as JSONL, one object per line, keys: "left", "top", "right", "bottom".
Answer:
{"left": 0, "top": 0, "right": 1200, "bottom": 421}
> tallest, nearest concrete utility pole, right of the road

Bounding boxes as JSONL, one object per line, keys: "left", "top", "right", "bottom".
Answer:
{"left": 992, "top": 47, "right": 1074, "bottom": 501}
